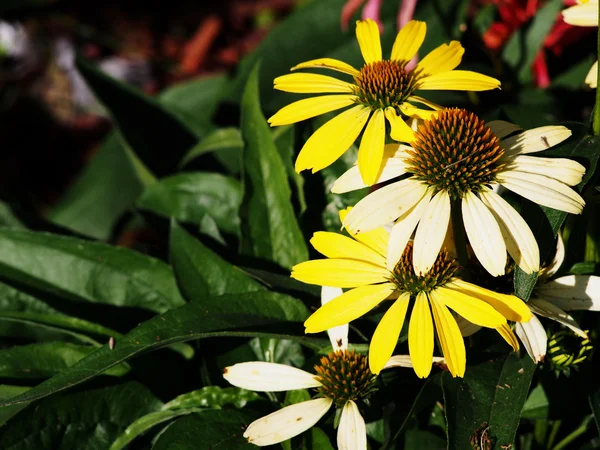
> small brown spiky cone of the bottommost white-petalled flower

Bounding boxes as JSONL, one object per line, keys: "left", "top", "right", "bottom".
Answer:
{"left": 315, "top": 350, "right": 376, "bottom": 407}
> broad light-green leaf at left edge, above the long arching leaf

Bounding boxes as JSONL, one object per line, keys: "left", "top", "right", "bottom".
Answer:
{"left": 0, "top": 229, "right": 184, "bottom": 312}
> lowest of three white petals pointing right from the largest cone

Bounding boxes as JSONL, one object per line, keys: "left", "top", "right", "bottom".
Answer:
{"left": 498, "top": 171, "right": 585, "bottom": 214}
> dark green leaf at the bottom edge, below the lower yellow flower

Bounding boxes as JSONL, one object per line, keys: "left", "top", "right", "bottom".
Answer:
{"left": 442, "top": 352, "right": 535, "bottom": 450}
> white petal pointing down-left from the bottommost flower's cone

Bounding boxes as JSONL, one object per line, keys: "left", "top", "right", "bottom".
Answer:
{"left": 244, "top": 398, "right": 333, "bottom": 447}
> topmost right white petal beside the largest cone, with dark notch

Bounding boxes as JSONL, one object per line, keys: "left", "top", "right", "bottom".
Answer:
{"left": 501, "top": 125, "right": 572, "bottom": 156}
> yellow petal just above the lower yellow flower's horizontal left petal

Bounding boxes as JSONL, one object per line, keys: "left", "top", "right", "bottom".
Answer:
{"left": 310, "top": 231, "right": 385, "bottom": 267}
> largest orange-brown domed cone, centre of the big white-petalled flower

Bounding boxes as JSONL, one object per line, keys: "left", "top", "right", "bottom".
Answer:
{"left": 406, "top": 108, "right": 504, "bottom": 199}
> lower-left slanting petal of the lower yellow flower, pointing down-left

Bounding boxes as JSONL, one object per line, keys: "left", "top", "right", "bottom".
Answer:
{"left": 304, "top": 283, "right": 396, "bottom": 333}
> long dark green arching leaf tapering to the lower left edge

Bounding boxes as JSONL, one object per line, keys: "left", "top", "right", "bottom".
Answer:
{"left": 0, "top": 292, "right": 321, "bottom": 406}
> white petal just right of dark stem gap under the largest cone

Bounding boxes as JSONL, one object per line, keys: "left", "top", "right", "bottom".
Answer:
{"left": 462, "top": 192, "right": 506, "bottom": 277}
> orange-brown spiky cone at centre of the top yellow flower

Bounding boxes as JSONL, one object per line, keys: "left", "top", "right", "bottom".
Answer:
{"left": 354, "top": 61, "right": 415, "bottom": 109}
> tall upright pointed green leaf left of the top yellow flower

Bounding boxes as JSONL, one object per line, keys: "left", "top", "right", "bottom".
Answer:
{"left": 240, "top": 66, "right": 308, "bottom": 268}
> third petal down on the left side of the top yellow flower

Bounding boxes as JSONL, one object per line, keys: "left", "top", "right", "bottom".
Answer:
{"left": 268, "top": 94, "right": 356, "bottom": 127}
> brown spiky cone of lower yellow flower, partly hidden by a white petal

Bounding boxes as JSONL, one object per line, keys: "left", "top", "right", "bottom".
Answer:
{"left": 390, "top": 242, "right": 458, "bottom": 295}
